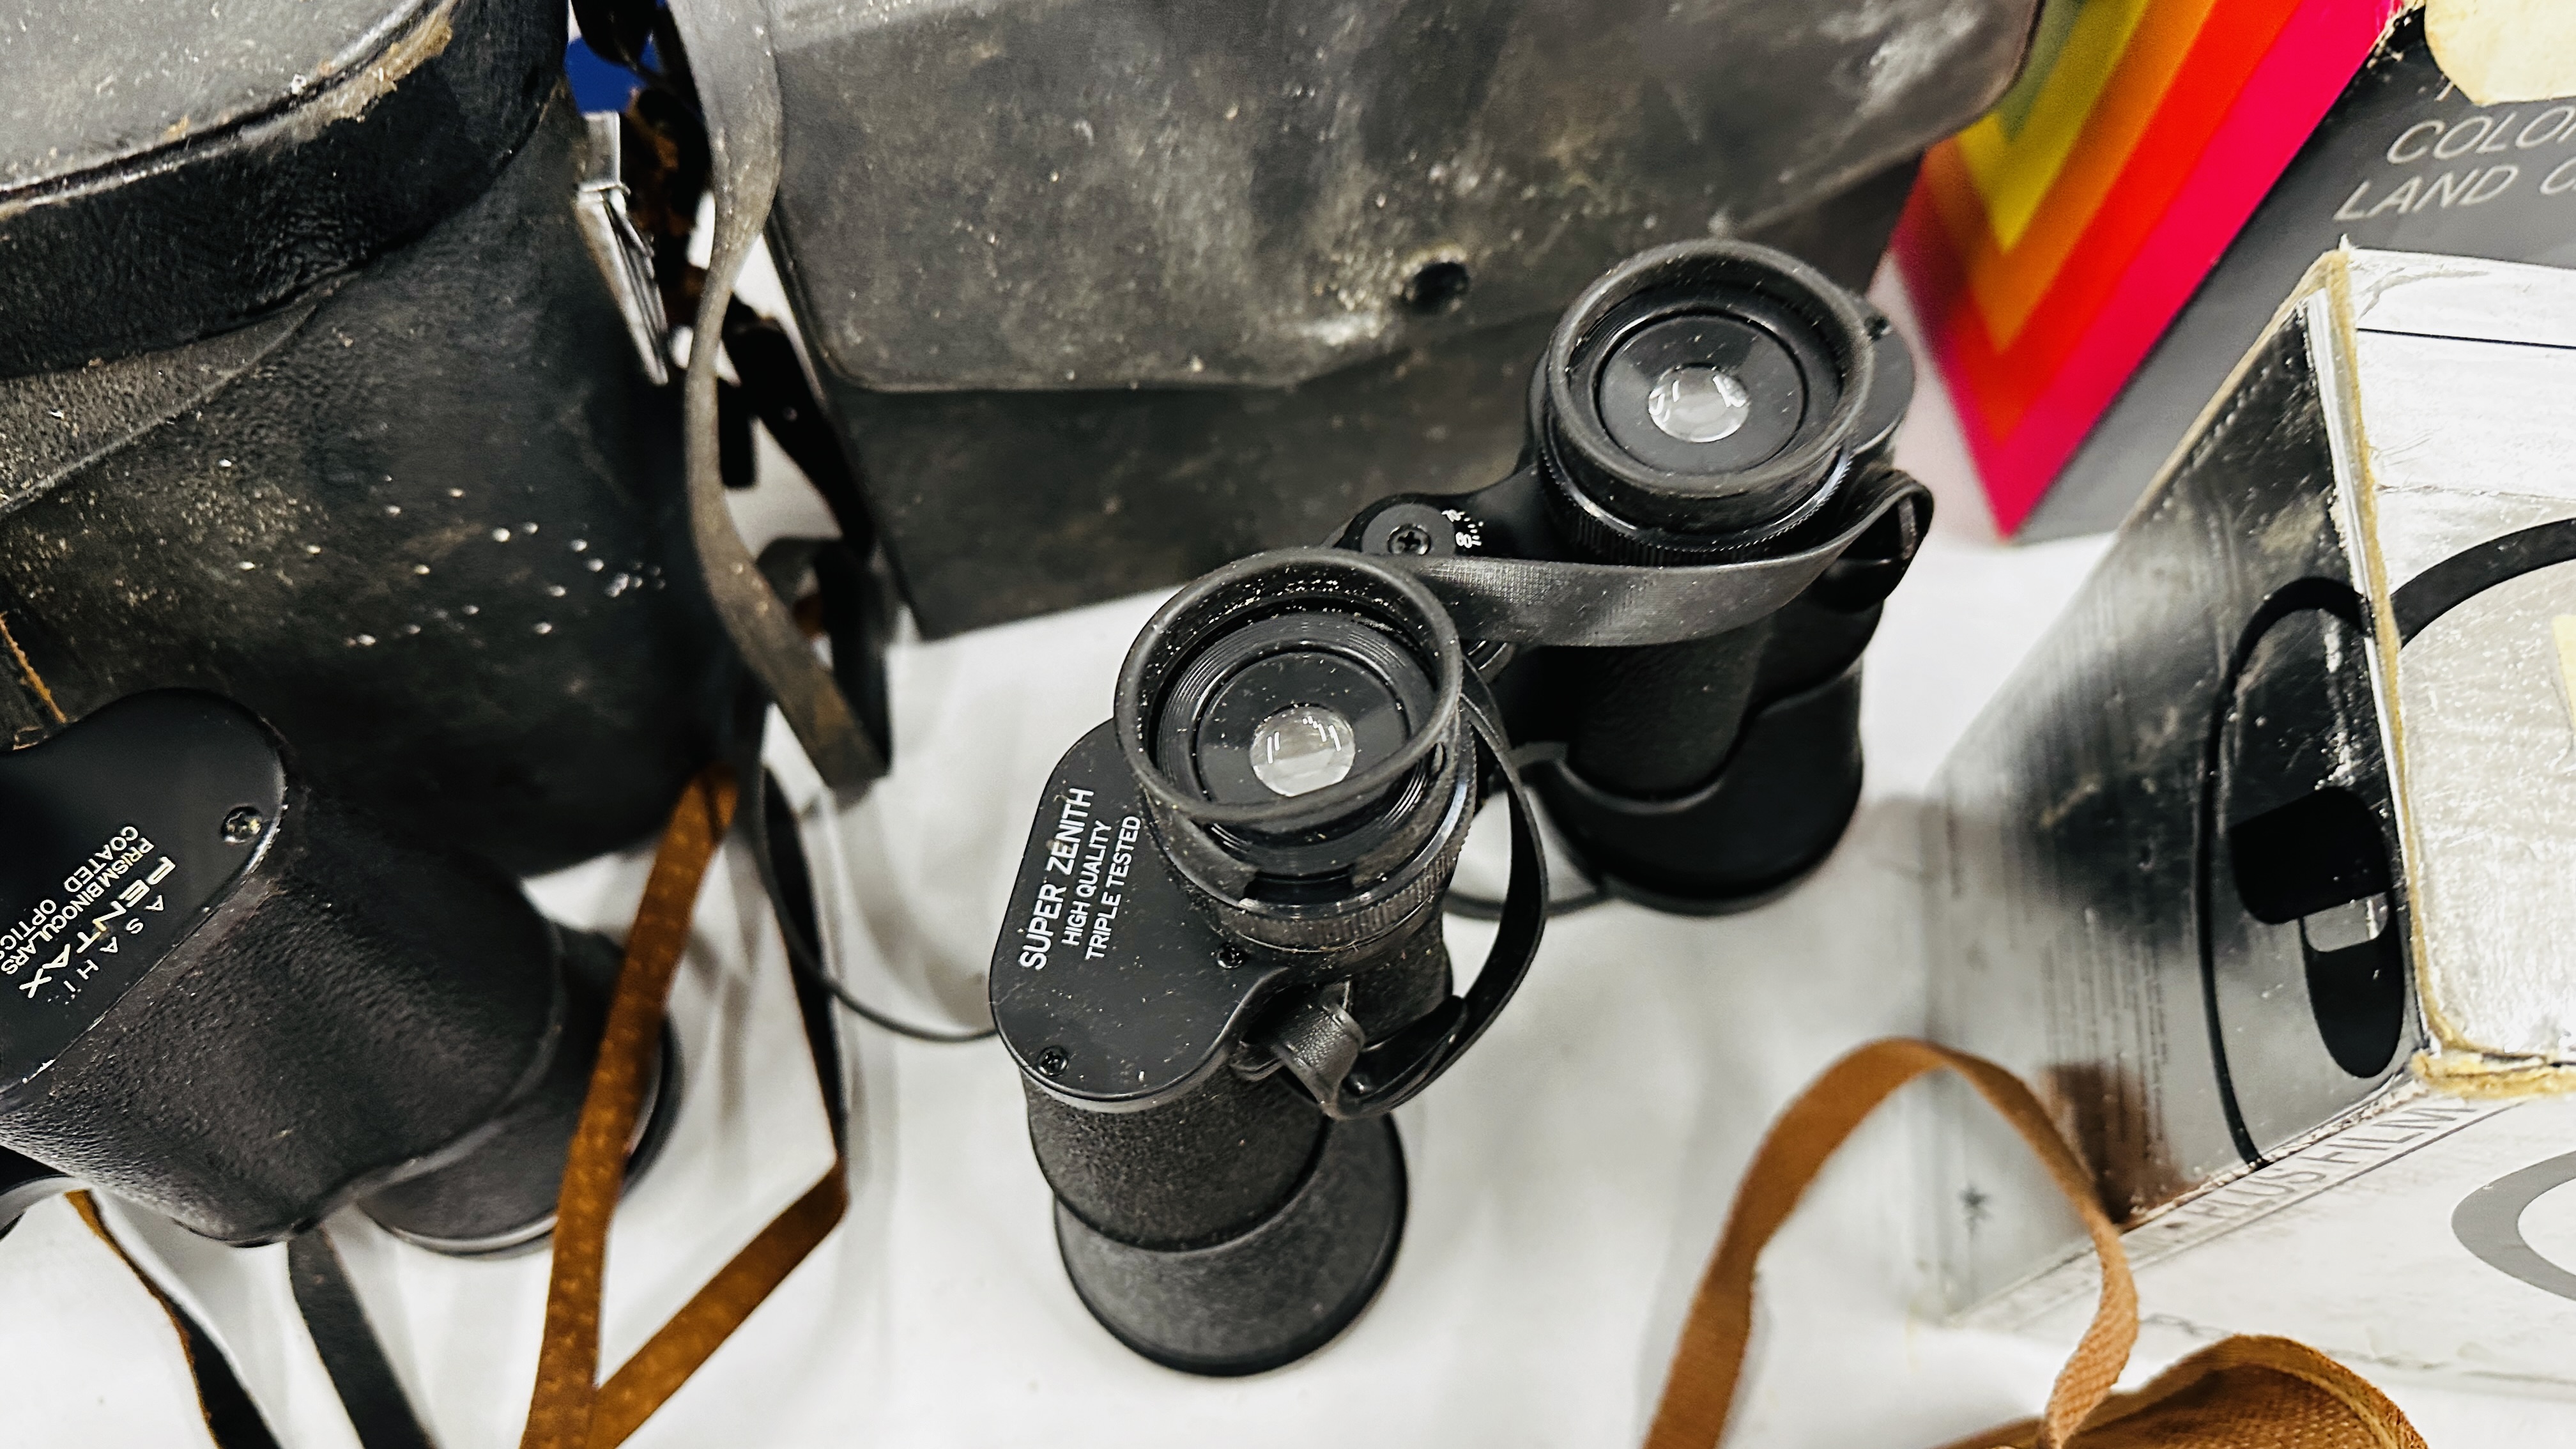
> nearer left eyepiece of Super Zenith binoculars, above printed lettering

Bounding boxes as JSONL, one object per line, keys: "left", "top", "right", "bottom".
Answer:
{"left": 1116, "top": 549, "right": 1476, "bottom": 951}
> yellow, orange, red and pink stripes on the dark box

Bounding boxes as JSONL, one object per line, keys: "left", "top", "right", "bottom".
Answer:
{"left": 1896, "top": 0, "right": 2406, "bottom": 533}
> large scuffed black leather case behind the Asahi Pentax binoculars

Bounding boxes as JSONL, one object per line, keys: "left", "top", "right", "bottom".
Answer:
{"left": 0, "top": 0, "right": 734, "bottom": 874}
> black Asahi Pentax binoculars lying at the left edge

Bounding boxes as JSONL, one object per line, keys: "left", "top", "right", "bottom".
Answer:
{"left": 0, "top": 691, "right": 677, "bottom": 1255}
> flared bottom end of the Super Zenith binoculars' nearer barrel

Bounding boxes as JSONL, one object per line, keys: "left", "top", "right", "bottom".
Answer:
{"left": 1056, "top": 1116, "right": 1406, "bottom": 1377}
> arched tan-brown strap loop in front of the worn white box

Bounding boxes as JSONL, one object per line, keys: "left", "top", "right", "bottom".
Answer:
{"left": 1646, "top": 1039, "right": 2138, "bottom": 1449}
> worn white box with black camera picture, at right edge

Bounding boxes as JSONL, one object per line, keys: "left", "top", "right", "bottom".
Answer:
{"left": 1927, "top": 250, "right": 2576, "bottom": 1384}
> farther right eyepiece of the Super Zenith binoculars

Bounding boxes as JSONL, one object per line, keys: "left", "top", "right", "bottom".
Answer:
{"left": 1530, "top": 242, "right": 1875, "bottom": 551}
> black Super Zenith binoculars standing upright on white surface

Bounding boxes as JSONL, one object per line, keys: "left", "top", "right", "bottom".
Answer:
{"left": 992, "top": 242, "right": 1932, "bottom": 1374}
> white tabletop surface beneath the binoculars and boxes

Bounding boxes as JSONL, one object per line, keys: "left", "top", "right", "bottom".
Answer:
{"left": 0, "top": 261, "right": 2576, "bottom": 1449}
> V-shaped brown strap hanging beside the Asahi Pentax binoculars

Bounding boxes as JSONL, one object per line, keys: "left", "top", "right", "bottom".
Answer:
{"left": 520, "top": 766, "right": 848, "bottom": 1449}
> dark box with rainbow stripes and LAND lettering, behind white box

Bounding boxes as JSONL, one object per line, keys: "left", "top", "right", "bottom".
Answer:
{"left": 1894, "top": 0, "right": 2576, "bottom": 539}
